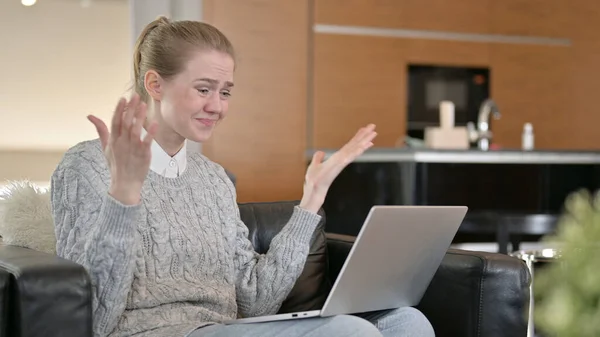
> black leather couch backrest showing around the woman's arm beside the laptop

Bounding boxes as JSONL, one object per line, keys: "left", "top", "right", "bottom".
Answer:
{"left": 239, "top": 201, "right": 331, "bottom": 313}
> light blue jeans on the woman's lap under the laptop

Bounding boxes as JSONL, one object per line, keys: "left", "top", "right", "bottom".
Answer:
{"left": 189, "top": 307, "right": 435, "bottom": 337}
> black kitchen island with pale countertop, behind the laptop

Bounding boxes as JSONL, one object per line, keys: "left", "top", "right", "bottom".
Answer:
{"left": 314, "top": 148, "right": 600, "bottom": 254}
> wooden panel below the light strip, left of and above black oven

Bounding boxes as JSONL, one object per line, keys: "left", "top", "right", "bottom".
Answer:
{"left": 312, "top": 34, "right": 490, "bottom": 148}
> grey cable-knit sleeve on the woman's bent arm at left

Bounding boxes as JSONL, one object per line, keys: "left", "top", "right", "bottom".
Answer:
{"left": 51, "top": 165, "right": 141, "bottom": 337}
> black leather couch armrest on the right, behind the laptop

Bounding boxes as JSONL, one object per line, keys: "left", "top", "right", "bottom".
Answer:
{"left": 327, "top": 233, "right": 531, "bottom": 337}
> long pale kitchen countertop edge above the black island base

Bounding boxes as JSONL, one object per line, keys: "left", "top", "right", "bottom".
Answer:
{"left": 306, "top": 148, "right": 600, "bottom": 164}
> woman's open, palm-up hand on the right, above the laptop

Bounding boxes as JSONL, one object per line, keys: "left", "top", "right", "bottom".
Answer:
{"left": 300, "top": 124, "right": 377, "bottom": 213}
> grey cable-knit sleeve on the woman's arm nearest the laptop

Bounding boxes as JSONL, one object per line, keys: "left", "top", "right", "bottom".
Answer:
{"left": 235, "top": 204, "right": 321, "bottom": 317}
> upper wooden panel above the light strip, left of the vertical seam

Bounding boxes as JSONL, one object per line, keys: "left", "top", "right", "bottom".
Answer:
{"left": 315, "top": 0, "right": 494, "bottom": 33}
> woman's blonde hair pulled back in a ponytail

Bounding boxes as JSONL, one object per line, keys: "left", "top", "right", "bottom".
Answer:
{"left": 133, "top": 16, "right": 235, "bottom": 102}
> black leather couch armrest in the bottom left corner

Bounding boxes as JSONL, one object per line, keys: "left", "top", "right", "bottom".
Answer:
{"left": 0, "top": 244, "right": 92, "bottom": 337}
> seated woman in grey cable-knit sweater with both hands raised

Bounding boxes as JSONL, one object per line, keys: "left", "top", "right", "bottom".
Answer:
{"left": 52, "top": 18, "right": 433, "bottom": 337}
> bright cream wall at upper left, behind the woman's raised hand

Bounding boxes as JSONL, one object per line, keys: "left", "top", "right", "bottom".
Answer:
{"left": 0, "top": 0, "right": 131, "bottom": 150}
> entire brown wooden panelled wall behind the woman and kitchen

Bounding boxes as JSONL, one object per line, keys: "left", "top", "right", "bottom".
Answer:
{"left": 199, "top": 0, "right": 600, "bottom": 201}
